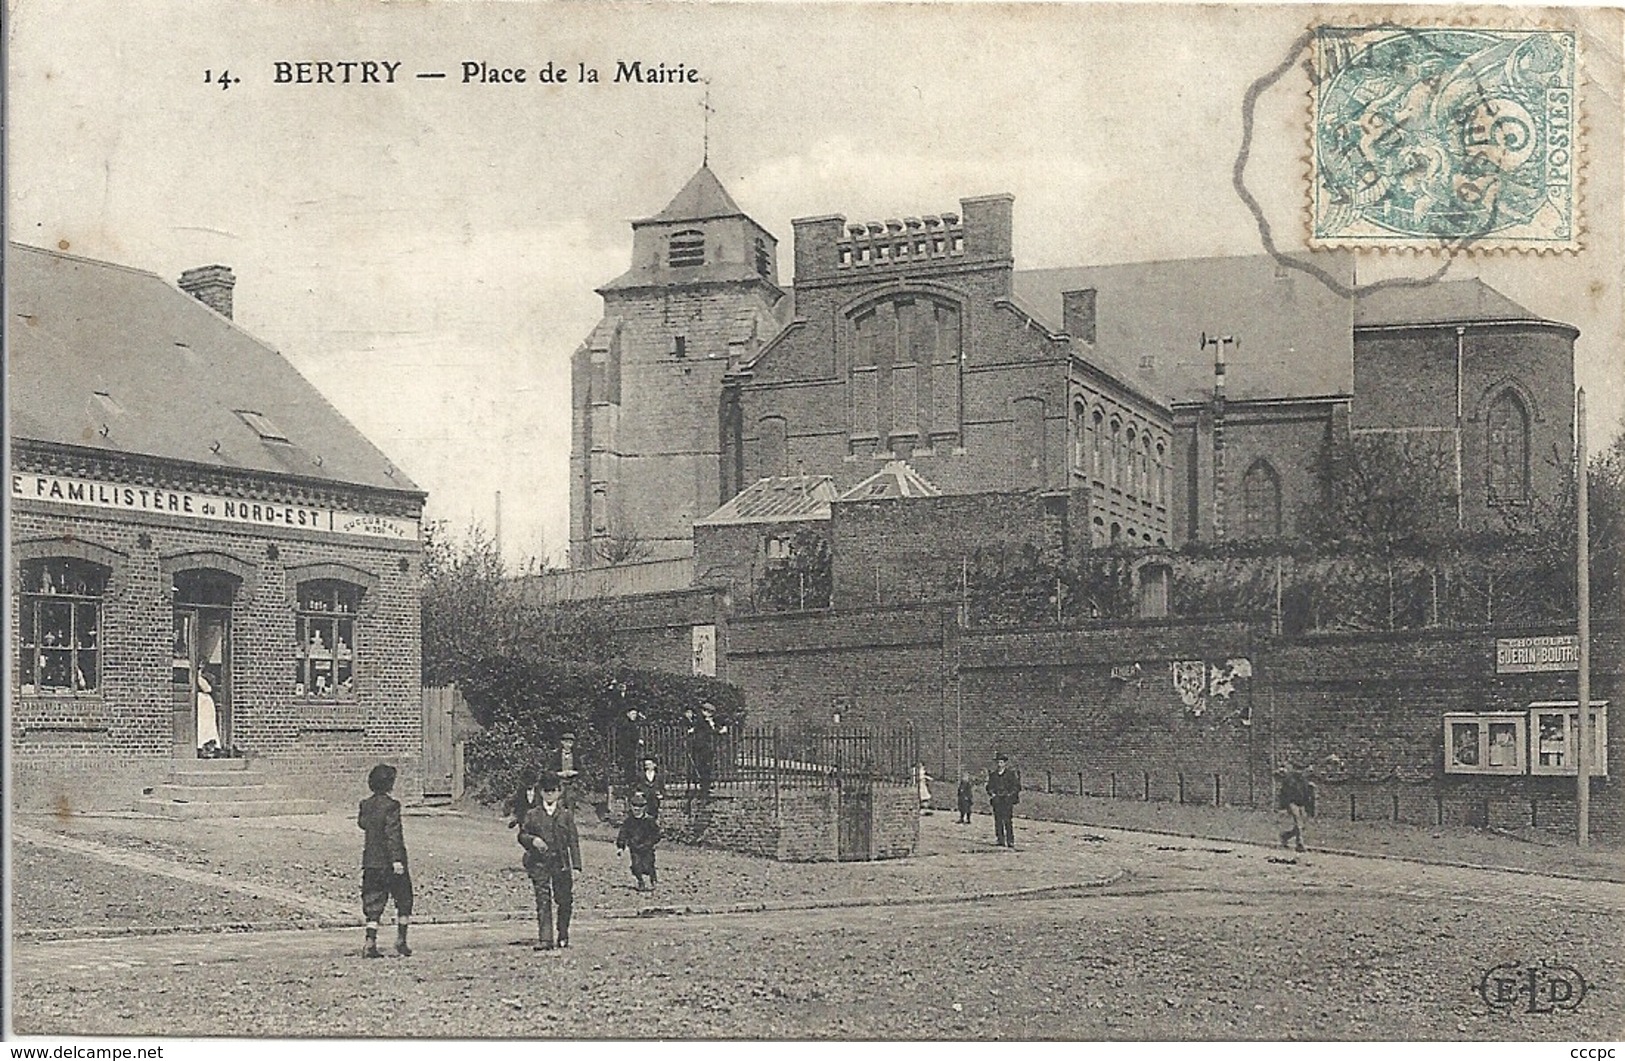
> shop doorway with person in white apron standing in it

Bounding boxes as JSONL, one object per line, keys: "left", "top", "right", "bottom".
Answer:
{"left": 171, "top": 570, "right": 237, "bottom": 759}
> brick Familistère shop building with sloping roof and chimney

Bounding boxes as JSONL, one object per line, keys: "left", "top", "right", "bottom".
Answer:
{"left": 7, "top": 244, "right": 424, "bottom": 809}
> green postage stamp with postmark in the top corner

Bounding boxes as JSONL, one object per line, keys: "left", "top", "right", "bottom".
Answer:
{"left": 1310, "top": 24, "right": 1581, "bottom": 250}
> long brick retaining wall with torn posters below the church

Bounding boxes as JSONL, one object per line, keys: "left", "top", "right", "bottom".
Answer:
{"left": 624, "top": 591, "right": 1625, "bottom": 834}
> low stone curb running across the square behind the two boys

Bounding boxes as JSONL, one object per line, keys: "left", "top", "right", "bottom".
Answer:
{"left": 11, "top": 869, "right": 1126, "bottom": 942}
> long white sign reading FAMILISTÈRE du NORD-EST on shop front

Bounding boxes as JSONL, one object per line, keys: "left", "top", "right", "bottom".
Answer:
{"left": 11, "top": 473, "right": 418, "bottom": 541}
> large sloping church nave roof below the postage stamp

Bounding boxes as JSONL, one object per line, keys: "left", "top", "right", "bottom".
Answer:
{"left": 1014, "top": 255, "right": 1354, "bottom": 401}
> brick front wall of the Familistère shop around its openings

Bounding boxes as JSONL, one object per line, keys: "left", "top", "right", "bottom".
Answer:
{"left": 10, "top": 474, "right": 423, "bottom": 806}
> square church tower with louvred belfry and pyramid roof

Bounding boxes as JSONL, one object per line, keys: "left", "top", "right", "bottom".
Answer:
{"left": 570, "top": 166, "right": 788, "bottom": 567}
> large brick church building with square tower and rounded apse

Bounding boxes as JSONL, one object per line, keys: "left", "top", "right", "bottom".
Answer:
{"left": 570, "top": 167, "right": 1578, "bottom": 567}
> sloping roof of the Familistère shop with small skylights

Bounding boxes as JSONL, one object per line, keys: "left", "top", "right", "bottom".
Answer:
{"left": 7, "top": 244, "right": 418, "bottom": 494}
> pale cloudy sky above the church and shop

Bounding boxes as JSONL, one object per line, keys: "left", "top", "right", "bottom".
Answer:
{"left": 7, "top": 0, "right": 1625, "bottom": 564}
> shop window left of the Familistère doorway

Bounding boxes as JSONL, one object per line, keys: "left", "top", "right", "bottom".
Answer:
{"left": 18, "top": 557, "right": 112, "bottom": 695}
